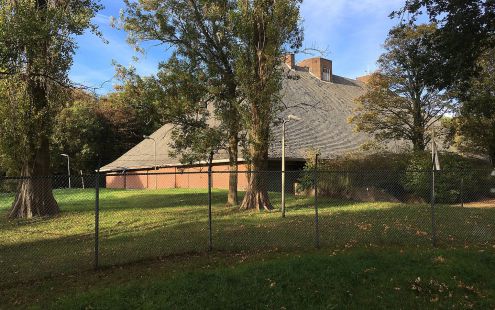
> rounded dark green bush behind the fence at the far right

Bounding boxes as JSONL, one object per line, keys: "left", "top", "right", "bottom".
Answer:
{"left": 402, "top": 153, "right": 491, "bottom": 203}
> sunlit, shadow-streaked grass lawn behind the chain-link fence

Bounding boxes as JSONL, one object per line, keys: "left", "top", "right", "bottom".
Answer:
{"left": 0, "top": 189, "right": 495, "bottom": 286}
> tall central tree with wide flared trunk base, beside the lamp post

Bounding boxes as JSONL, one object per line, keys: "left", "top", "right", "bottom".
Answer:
{"left": 234, "top": 0, "right": 303, "bottom": 210}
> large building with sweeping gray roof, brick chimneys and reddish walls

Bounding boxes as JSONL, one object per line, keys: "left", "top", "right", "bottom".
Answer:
{"left": 101, "top": 55, "right": 388, "bottom": 189}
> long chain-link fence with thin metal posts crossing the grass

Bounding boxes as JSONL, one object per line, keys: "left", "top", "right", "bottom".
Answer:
{"left": 0, "top": 170, "right": 495, "bottom": 283}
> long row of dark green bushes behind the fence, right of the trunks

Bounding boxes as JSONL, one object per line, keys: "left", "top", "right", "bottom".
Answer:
{"left": 299, "top": 152, "right": 493, "bottom": 203}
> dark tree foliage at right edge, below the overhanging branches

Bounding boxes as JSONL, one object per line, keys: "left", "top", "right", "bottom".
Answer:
{"left": 453, "top": 50, "right": 495, "bottom": 164}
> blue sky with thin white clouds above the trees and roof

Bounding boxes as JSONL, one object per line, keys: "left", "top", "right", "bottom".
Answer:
{"left": 70, "top": 0, "right": 410, "bottom": 94}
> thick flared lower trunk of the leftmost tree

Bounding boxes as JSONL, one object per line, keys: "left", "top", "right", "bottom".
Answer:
{"left": 9, "top": 137, "right": 60, "bottom": 219}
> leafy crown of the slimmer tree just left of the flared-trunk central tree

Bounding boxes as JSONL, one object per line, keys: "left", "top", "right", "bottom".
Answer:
{"left": 121, "top": 0, "right": 242, "bottom": 164}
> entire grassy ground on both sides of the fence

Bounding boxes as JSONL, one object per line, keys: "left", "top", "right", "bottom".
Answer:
{"left": 0, "top": 190, "right": 495, "bottom": 308}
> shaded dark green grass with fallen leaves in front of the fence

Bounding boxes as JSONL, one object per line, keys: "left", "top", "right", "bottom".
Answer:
{"left": 14, "top": 248, "right": 495, "bottom": 309}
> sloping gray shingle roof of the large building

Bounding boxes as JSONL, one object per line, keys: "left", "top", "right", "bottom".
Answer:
{"left": 102, "top": 68, "right": 386, "bottom": 171}
